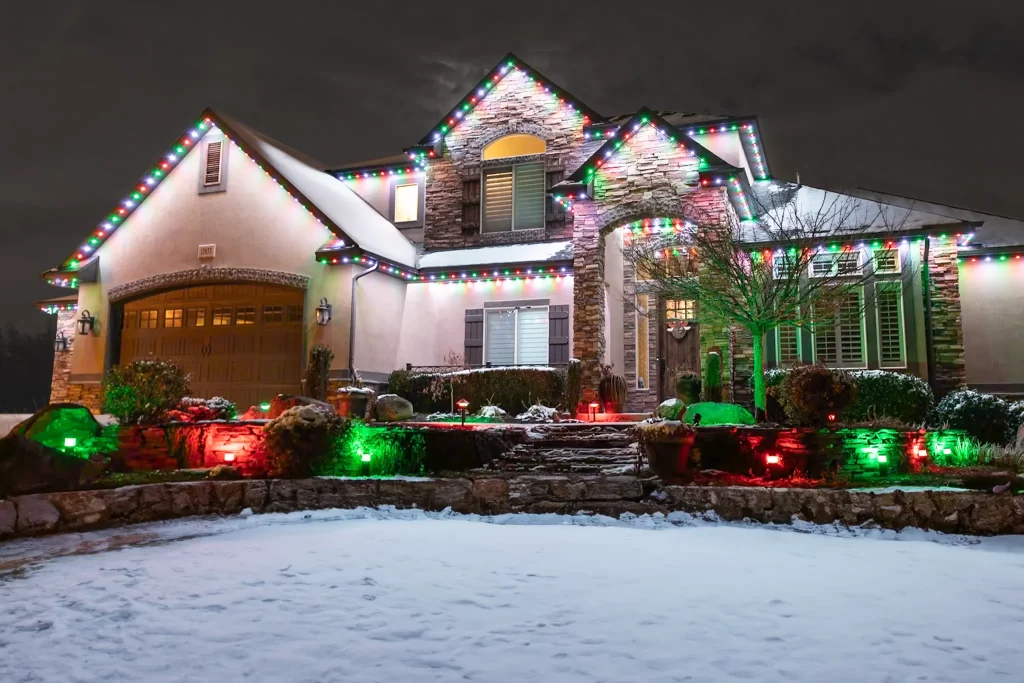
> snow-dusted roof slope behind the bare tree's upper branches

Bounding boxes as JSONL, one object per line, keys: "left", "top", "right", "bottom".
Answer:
{"left": 752, "top": 181, "right": 965, "bottom": 241}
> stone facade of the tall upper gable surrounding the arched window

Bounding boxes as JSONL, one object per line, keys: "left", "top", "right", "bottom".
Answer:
{"left": 424, "top": 71, "right": 600, "bottom": 250}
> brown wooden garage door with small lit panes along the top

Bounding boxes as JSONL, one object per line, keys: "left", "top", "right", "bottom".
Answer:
{"left": 121, "top": 285, "right": 303, "bottom": 411}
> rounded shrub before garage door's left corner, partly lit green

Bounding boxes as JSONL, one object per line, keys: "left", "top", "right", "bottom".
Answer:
{"left": 103, "top": 360, "right": 188, "bottom": 425}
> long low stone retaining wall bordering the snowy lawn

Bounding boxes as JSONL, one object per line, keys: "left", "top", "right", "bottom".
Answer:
{"left": 0, "top": 476, "right": 1024, "bottom": 539}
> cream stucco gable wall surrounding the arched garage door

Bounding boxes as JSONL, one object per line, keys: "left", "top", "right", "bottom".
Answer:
{"left": 72, "top": 133, "right": 350, "bottom": 381}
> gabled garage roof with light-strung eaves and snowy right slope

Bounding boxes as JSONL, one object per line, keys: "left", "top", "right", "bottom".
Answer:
{"left": 42, "top": 109, "right": 416, "bottom": 287}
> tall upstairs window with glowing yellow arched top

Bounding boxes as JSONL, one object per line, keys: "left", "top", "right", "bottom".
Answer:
{"left": 480, "top": 133, "right": 547, "bottom": 232}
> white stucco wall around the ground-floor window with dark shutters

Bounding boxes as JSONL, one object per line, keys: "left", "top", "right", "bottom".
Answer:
{"left": 397, "top": 278, "right": 573, "bottom": 368}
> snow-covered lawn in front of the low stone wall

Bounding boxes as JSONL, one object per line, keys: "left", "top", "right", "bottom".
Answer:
{"left": 0, "top": 510, "right": 1024, "bottom": 683}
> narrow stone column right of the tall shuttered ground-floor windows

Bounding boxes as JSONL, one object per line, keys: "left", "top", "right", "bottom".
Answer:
{"left": 927, "top": 239, "right": 967, "bottom": 398}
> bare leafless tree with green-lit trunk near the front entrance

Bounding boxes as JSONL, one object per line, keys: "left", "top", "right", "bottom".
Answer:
{"left": 623, "top": 183, "right": 910, "bottom": 420}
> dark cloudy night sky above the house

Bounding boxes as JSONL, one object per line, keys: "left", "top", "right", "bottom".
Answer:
{"left": 0, "top": 0, "right": 1024, "bottom": 330}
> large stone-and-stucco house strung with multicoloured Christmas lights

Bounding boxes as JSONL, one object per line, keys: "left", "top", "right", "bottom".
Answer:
{"left": 40, "top": 54, "right": 1024, "bottom": 411}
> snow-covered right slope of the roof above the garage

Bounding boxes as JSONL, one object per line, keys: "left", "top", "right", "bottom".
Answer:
{"left": 218, "top": 115, "right": 416, "bottom": 267}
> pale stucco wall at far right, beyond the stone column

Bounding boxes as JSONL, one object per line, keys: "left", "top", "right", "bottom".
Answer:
{"left": 959, "top": 259, "right": 1024, "bottom": 392}
